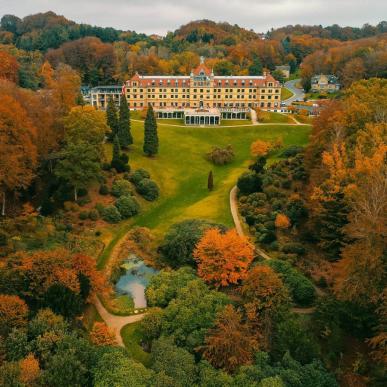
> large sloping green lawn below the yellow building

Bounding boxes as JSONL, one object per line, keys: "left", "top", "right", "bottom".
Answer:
{"left": 98, "top": 123, "right": 310, "bottom": 268}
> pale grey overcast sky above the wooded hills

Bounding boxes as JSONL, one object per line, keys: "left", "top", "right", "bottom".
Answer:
{"left": 0, "top": 0, "right": 387, "bottom": 35}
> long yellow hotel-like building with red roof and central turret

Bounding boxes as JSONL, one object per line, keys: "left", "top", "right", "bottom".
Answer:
{"left": 91, "top": 58, "right": 281, "bottom": 125}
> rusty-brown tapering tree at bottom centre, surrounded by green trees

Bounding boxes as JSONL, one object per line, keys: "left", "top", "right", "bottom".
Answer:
{"left": 201, "top": 305, "right": 258, "bottom": 372}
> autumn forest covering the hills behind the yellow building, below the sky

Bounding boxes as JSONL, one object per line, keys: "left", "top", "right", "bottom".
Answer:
{"left": 0, "top": 12, "right": 387, "bottom": 89}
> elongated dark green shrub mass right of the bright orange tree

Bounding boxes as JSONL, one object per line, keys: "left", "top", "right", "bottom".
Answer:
{"left": 268, "top": 259, "right": 316, "bottom": 306}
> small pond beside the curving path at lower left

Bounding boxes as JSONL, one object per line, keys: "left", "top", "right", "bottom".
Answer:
{"left": 116, "top": 255, "right": 158, "bottom": 308}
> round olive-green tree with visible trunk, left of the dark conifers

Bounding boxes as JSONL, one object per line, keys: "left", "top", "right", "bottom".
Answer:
{"left": 55, "top": 142, "right": 101, "bottom": 201}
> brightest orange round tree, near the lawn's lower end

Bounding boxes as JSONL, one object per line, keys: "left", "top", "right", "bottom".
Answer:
{"left": 193, "top": 228, "right": 254, "bottom": 286}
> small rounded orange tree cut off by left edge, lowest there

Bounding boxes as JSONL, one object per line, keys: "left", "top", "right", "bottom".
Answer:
{"left": 0, "top": 294, "right": 28, "bottom": 336}
